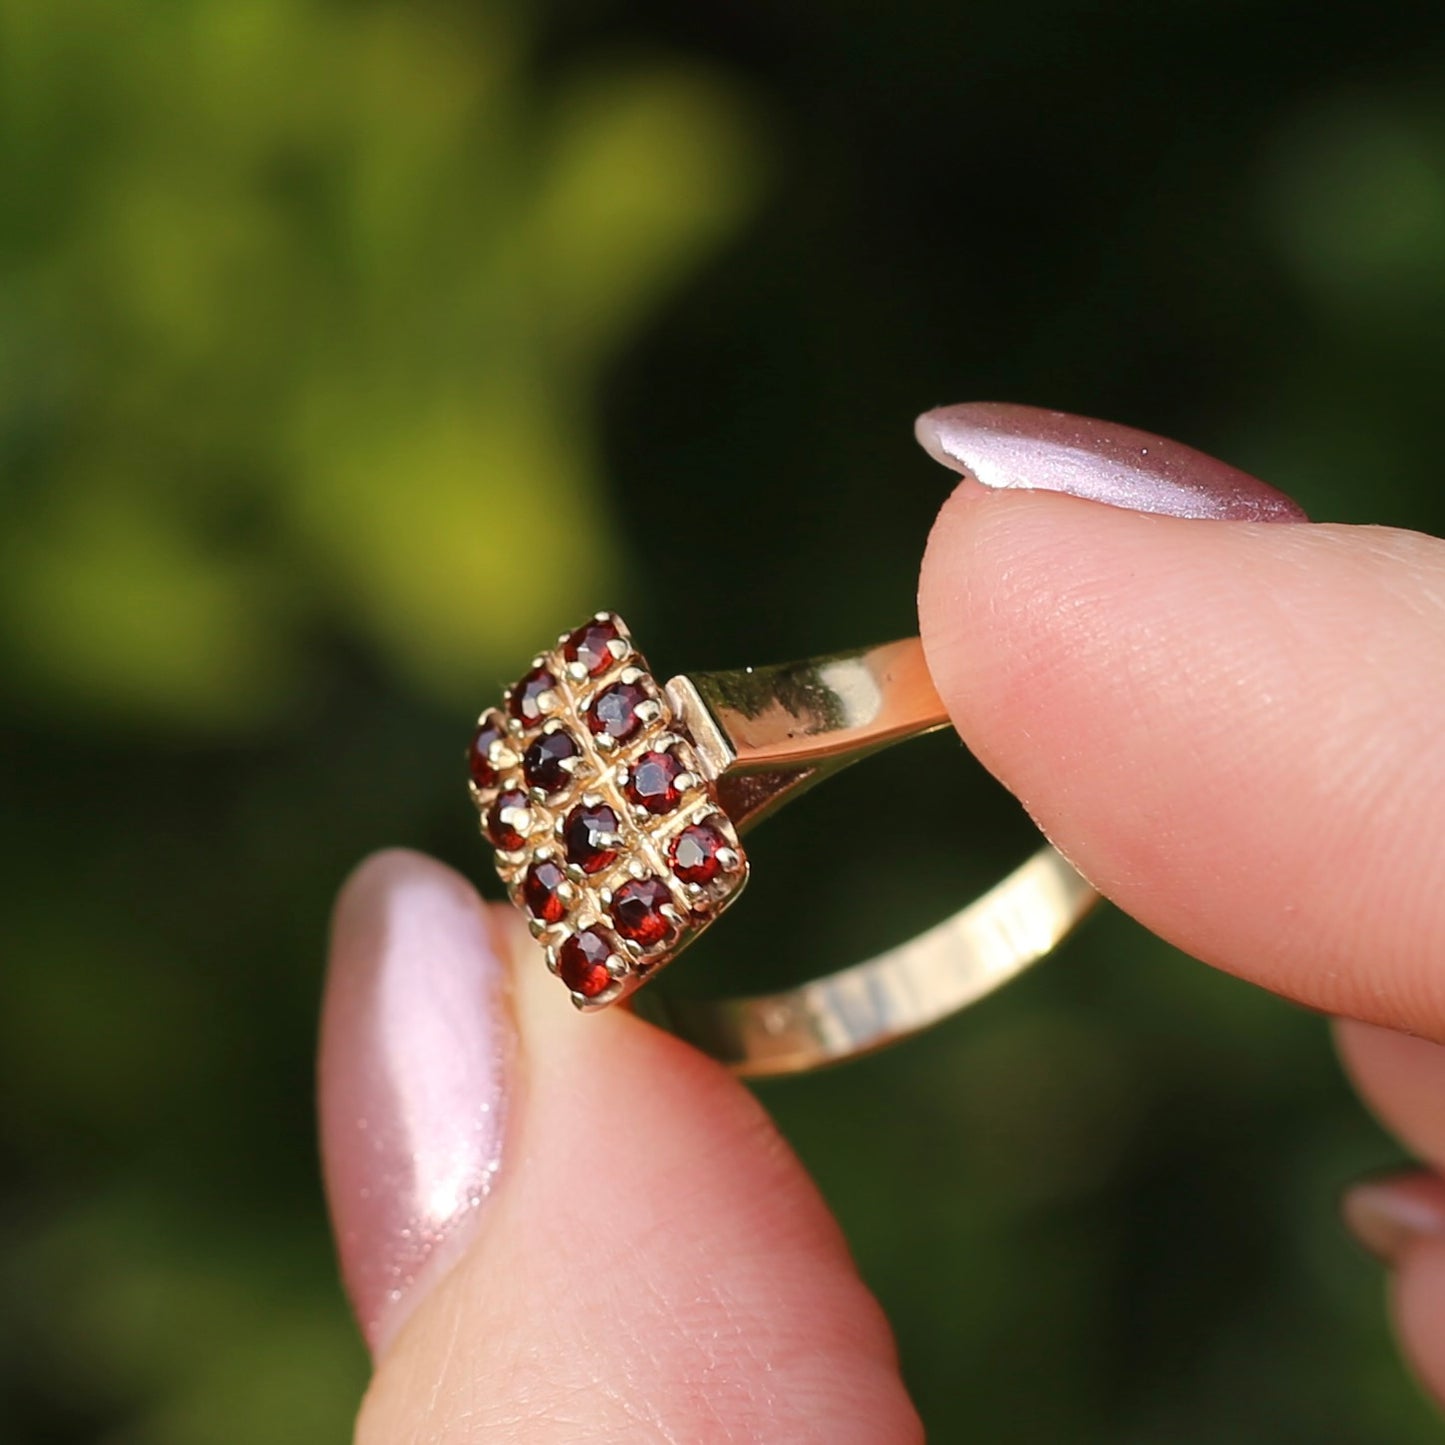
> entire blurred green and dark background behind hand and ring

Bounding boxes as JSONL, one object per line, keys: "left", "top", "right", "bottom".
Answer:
{"left": 0, "top": 0, "right": 1445, "bottom": 1445}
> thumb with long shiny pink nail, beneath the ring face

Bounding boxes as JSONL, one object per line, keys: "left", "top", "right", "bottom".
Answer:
{"left": 321, "top": 853, "right": 920, "bottom": 1445}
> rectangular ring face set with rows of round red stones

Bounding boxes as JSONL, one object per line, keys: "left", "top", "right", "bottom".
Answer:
{"left": 468, "top": 613, "right": 747, "bottom": 1009}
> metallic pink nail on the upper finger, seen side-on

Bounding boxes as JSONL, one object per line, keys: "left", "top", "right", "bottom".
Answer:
{"left": 915, "top": 402, "right": 1308, "bottom": 522}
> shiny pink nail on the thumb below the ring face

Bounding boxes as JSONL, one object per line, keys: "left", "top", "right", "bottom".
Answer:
{"left": 319, "top": 851, "right": 514, "bottom": 1354}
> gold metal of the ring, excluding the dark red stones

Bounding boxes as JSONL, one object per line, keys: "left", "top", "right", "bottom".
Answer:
{"left": 473, "top": 613, "right": 1098, "bottom": 1075}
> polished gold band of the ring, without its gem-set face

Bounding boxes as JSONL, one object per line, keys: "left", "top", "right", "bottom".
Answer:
{"left": 636, "top": 637, "right": 1098, "bottom": 1075}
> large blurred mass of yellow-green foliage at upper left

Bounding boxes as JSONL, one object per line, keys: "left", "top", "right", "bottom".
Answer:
{"left": 0, "top": 0, "right": 757, "bottom": 730}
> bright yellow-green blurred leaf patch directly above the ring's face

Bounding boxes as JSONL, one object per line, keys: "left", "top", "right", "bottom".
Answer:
{"left": 288, "top": 377, "right": 613, "bottom": 693}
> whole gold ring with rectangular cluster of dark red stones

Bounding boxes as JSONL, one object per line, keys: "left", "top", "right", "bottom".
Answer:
{"left": 468, "top": 613, "right": 1098, "bottom": 1075}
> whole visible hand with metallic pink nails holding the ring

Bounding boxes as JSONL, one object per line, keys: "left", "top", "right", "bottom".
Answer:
{"left": 321, "top": 407, "right": 1445, "bottom": 1445}
